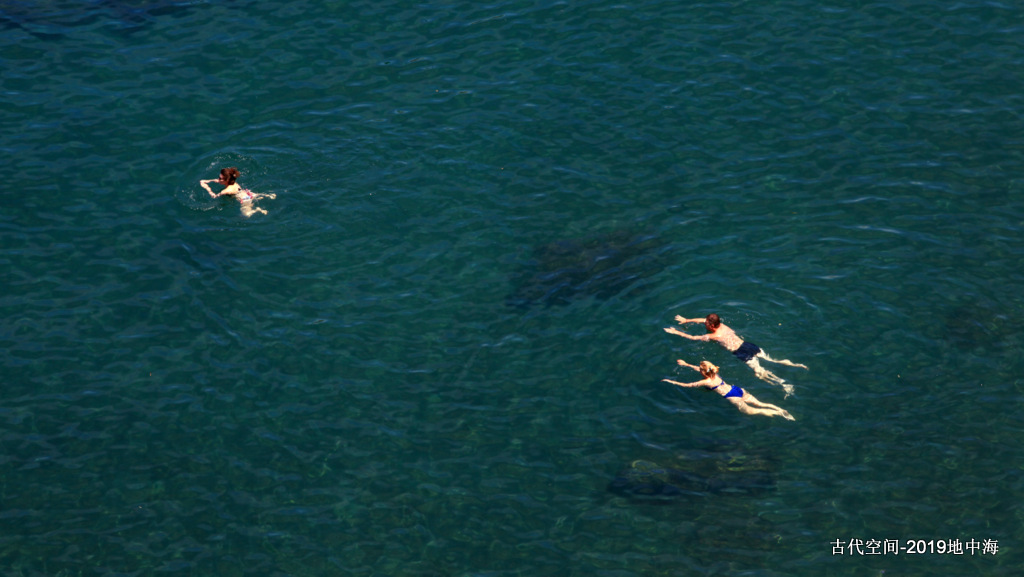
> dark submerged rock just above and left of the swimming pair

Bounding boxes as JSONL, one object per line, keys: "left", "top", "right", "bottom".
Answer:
{"left": 506, "top": 231, "right": 666, "bottom": 307}
